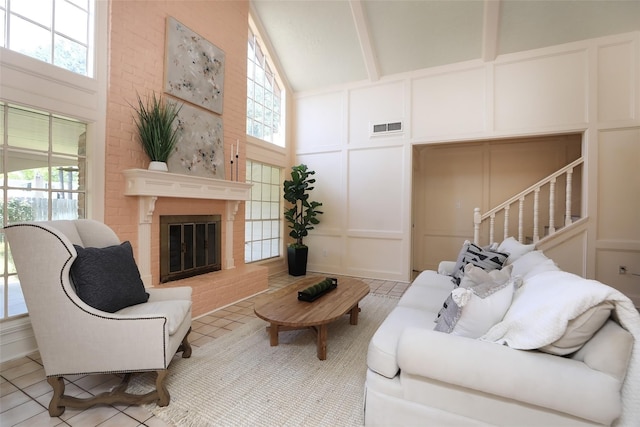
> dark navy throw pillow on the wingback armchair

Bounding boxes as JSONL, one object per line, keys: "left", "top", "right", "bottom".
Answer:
{"left": 71, "top": 242, "right": 149, "bottom": 313}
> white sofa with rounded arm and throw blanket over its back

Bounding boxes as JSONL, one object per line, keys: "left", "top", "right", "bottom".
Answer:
{"left": 365, "top": 239, "right": 640, "bottom": 426}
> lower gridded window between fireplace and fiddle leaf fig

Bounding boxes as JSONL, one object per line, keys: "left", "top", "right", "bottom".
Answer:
{"left": 244, "top": 160, "right": 282, "bottom": 262}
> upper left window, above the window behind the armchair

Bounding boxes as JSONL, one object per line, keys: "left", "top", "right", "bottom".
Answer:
{"left": 0, "top": 0, "right": 93, "bottom": 77}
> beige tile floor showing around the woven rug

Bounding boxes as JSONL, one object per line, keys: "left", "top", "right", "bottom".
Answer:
{"left": 0, "top": 273, "right": 409, "bottom": 427}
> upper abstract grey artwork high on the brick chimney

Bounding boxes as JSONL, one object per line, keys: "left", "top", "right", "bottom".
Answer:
{"left": 165, "top": 17, "right": 224, "bottom": 114}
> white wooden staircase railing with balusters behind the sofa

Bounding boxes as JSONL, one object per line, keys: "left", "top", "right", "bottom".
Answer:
{"left": 473, "top": 157, "right": 584, "bottom": 245}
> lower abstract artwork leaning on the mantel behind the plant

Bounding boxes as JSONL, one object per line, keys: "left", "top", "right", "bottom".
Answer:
{"left": 167, "top": 104, "right": 225, "bottom": 179}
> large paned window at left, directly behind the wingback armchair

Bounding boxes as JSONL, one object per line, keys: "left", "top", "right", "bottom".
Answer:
{"left": 0, "top": 103, "right": 87, "bottom": 319}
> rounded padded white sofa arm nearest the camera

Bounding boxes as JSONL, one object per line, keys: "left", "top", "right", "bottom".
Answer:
{"left": 398, "top": 328, "right": 622, "bottom": 425}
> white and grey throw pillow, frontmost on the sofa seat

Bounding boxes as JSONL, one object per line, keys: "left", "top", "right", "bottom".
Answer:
{"left": 434, "top": 264, "right": 520, "bottom": 338}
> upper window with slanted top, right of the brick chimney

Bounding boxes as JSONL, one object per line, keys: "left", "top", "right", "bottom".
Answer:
{"left": 247, "top": 26, "right": 284, "bottom": 147}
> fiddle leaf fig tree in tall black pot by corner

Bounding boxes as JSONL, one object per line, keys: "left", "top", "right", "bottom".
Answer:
{"left": 284, "top": 164, "right": 323, "bottom": 276}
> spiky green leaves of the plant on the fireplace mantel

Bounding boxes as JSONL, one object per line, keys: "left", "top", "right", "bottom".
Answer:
{"left": 133, "top": 92, "right": 182, "bottom": 162}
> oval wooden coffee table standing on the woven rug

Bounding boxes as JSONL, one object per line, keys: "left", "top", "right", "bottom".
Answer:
{"left": 254, "top": 276, "right": 369, "bottom": 360}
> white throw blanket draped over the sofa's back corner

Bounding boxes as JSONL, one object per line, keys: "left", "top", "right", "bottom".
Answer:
{"left": 480, "top": 271, "right": 640, "bottom": 426}
